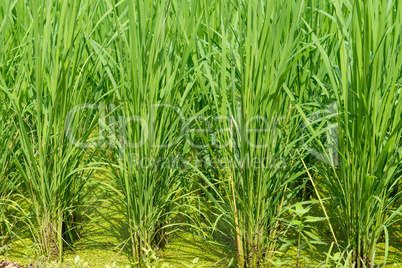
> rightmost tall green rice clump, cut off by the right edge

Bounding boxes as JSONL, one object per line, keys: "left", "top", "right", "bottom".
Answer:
{"left": 298, "top": 1, "right": 402, "bottom": 267}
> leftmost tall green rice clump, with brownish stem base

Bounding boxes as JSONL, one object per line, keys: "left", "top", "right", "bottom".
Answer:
{"left": 1, "top": 1, "right": 102, "bottom": 258}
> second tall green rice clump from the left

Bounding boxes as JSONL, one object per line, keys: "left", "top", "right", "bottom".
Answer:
{"left": 103, "top": 1, "right": 201, "bottom": 259}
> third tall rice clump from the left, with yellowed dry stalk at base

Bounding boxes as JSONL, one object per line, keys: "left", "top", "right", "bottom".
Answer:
{"left": 183, "top": 1, "right": 310, "bottom": 267}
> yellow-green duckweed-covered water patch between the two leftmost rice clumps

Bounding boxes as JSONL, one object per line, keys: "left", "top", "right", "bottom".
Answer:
{"left": 63, "top": 176, "right": 131, "bottom": 267}
